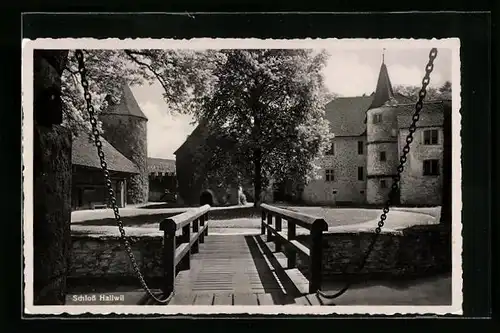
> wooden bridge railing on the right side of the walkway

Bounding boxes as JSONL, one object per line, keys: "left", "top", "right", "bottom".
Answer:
{"left": 260, "top": 204, "right": 328, "bottom": 293}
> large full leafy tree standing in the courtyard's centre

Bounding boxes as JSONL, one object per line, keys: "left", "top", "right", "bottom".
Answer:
{"left": 197, "top": 49, "right": 331, "bottom": 206}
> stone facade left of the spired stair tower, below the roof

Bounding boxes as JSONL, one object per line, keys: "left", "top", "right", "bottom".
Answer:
{"left": 302, "top": 136, "right": 366, "bottom": 204}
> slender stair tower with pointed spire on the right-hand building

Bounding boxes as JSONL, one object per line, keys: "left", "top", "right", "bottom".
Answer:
{"left": 366, "top": 62, "right": 399, "bottom": 204}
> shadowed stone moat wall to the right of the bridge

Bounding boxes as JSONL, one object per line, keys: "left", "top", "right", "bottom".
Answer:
{"left": 297, "top": 225, "right": 451, "bottom": 280}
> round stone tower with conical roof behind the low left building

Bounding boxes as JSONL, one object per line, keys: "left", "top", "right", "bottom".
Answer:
{"left": 100, "top": 86, "right": 149, "bottom": 204}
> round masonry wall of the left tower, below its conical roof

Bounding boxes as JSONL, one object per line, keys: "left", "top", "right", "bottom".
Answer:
{"left": 101, "top": 114, "right": 149, "bottom": 204}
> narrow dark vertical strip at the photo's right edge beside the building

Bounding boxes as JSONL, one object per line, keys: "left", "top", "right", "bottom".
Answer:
{"left": 440, "top": 102, "right": 452, "bottom": 228}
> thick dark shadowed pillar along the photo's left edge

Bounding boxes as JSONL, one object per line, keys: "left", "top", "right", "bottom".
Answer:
{"left": 32, "top": 50, "right": 72, "bottom": 305}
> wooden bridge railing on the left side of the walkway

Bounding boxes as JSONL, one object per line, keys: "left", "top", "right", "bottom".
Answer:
{"left": 160, "top": 205, "right": 210, "bottom": 295}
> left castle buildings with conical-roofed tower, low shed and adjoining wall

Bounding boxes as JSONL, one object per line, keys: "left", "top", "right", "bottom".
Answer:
{"left": 71, "top": 86, "right": 177, "bottom": 210}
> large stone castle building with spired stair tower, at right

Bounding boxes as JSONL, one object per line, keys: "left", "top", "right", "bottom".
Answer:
{"left": 302, "top": 58, "right": 451, "bottom": 205}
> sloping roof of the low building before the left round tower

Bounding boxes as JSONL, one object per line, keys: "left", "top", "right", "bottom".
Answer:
{"left": 71, "top": 133, "right": 139, "bottom": 173}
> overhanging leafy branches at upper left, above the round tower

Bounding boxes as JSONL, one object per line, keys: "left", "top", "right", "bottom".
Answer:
{"left": 61, "top": 49, "right": 218, "bottom": 134}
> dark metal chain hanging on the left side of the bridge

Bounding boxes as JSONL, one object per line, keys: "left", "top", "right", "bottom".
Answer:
{"left": 75, "top": 50, "right": 174, "bottom": 304}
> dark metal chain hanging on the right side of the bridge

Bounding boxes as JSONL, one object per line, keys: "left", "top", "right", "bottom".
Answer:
{"left": 317, "top": 48, "right": 437, "bottom": 299}
